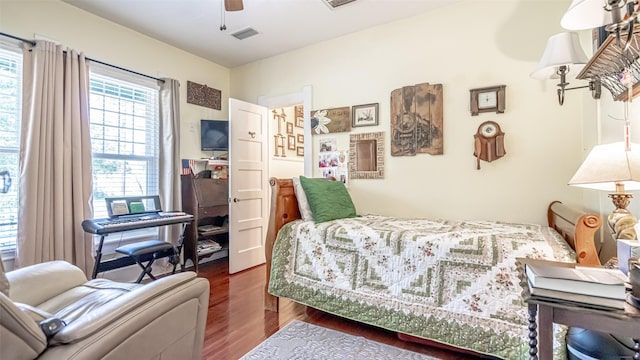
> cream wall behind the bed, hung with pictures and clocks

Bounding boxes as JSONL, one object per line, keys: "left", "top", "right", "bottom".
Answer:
{"left": 231, "top": 1, "right": 583, "bottom": 223}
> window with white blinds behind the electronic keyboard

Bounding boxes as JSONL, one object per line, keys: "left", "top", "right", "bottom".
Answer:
{"left": 89, "top": 64, "right": 159, "bottom": 218}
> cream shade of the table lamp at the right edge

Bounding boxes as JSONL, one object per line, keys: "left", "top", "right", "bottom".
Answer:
{"left": 569, "top": 142, "right": 640, "bottom": 192}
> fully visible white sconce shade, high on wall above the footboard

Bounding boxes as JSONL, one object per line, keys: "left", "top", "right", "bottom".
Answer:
{"left": 530, "top": 32, "right": 589, "bottom": 80}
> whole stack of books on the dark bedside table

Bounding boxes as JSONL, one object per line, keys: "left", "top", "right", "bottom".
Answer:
{"left": 524, "top": 260, "right": 628, "bottom": 309}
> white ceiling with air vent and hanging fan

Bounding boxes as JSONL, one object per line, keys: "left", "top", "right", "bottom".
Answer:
{"left": 63, "top": 0, "right": 460, "bottom": 68}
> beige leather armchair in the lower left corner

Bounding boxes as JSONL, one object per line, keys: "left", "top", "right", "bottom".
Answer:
{"left": 0, "top": 261, "right": 209, "bottom": 360}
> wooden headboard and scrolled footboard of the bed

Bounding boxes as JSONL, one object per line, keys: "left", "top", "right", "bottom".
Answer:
{"left": 264, "top": 178, "right": 601, "bottom": 312}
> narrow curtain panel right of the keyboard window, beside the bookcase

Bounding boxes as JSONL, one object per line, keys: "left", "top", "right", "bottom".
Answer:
{"left": 159, "top": 79, "right": 182, "bottom": 249}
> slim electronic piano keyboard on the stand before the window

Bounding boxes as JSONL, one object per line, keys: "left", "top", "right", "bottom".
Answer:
{"left": 82, "top": 212, "right": 193, "bottom": 235}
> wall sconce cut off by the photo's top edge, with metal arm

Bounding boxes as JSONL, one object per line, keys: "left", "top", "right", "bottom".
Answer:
{"left": 560, "top": 0, "right": 638, "bottom": 50}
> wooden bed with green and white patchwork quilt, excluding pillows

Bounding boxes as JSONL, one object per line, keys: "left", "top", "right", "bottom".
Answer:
{"left": 265, "top": 178, "right": 601, "bottom": 359}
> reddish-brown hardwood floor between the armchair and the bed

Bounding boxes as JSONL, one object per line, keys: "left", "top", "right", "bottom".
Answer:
{"left": 198, "top": 259, "right": 477, "bottom": 360}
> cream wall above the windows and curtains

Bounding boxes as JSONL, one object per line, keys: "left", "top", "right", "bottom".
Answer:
{"left": 0, "top": 0, "right": 231, "bottom": 158}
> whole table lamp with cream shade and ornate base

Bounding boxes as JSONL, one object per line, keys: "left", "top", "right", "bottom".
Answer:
{"left": 569, "top": 141, "right": 640, "bottom": 239}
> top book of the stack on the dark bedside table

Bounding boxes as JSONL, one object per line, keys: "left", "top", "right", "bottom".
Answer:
{"left": 525, "top": 262, "right": 628, "bottom": 300}
